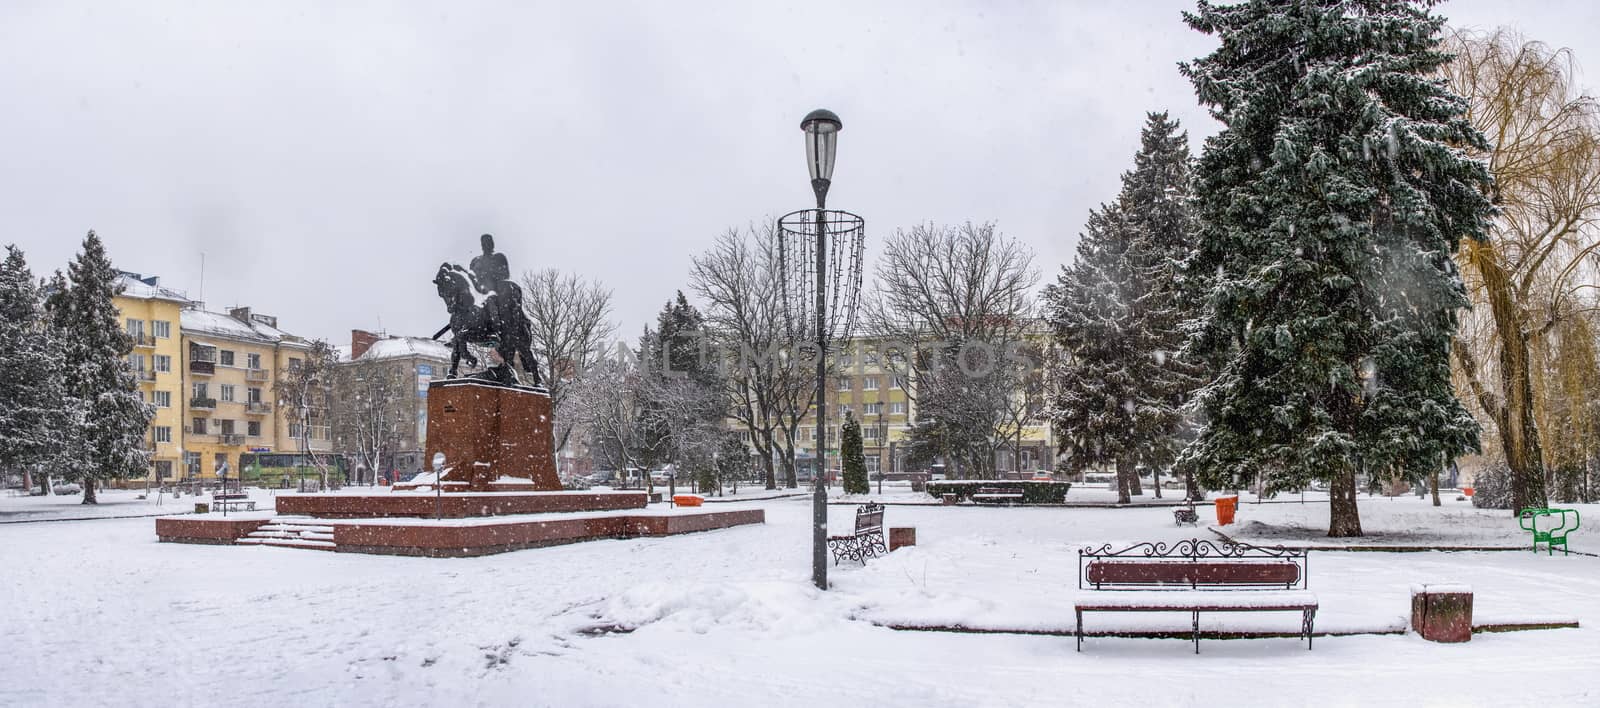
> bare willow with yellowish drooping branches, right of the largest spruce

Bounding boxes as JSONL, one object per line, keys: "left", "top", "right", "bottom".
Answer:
{"left": 1442, "top": 30, "right": 1600, "bottom": 511}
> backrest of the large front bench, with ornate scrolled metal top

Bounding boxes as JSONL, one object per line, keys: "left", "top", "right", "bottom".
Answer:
{"left": 1078, "top": 538, "right": 1309, "bottom": 589}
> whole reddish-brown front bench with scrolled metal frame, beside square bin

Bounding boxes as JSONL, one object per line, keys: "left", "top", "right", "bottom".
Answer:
{"left": 1075, "top": 538, "right": 1317, "bottom": 654}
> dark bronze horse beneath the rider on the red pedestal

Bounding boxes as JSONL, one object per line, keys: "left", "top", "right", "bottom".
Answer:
{"left": 434, "top": 263, "right": 541, "bottom": 386}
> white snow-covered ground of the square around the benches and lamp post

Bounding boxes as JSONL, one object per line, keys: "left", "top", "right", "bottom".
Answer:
{"left": 0, "top": 498, "right": 1600, "bottom": 706}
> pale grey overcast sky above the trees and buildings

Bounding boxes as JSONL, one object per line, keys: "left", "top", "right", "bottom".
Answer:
{"left": 0, "top": 0, "right": 1600, "bottom": 343}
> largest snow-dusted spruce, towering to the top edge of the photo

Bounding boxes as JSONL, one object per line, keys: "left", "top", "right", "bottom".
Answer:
{"left": 1179, "top": 0, "right": 1491, "bottom": 537}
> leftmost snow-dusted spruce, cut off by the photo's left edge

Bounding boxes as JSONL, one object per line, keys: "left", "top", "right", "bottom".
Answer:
{"left": 0, "top": 245, "right": 70, "bottom": 489}
